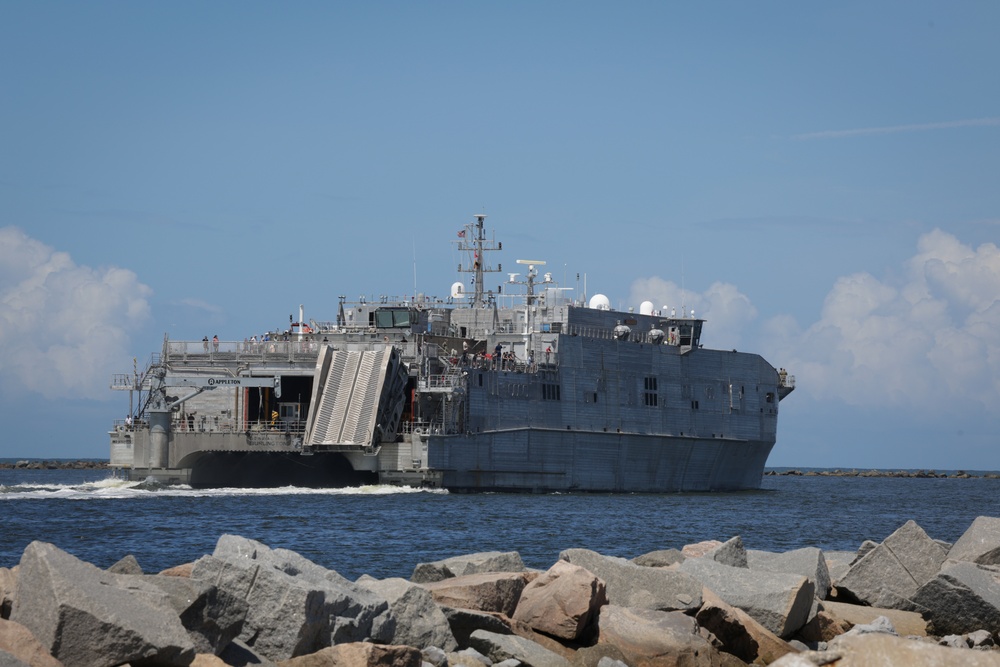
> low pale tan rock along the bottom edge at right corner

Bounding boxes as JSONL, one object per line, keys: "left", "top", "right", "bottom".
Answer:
{"left": 772, "top": 634, "right": 1000, "bottom": 667}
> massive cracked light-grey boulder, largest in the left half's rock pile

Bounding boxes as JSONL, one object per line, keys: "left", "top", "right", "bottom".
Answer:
{"left": 191, "top": 535, "right": 393, "bottom": 661}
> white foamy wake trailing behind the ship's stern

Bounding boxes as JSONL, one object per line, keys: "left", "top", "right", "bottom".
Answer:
{"left": 0, "top": 477, "right": 448, "bottom": 501}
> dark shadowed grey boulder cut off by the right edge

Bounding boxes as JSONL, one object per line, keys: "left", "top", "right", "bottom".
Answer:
{"left": 913, "top": 560, "right": 1000, "bottom": 635}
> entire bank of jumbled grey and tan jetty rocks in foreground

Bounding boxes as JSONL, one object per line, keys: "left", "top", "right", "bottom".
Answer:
{"left": 0, "top": 517, "right": 1000, "bottom": 667}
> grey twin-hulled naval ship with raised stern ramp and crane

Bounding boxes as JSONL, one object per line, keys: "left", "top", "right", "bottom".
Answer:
{"left": 110, "top": 215, "right": 795, "bottom": 492}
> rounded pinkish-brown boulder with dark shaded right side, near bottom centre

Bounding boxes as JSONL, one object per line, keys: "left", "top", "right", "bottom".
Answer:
{"left": 512, "top": 561, "right": 608, "bottom": 641}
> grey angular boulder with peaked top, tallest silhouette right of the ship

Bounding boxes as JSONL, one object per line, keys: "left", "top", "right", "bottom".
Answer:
{"left": 837, "top": 521, "right": 947, "bottom": 610}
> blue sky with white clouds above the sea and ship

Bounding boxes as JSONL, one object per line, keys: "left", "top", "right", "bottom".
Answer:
{"left": 0, "top": 2, "right": 1000, "bottom": 470}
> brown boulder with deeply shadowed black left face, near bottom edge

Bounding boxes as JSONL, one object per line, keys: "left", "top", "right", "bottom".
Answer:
{"left": 695, "top": 589, "right": 795, "bottom": 665}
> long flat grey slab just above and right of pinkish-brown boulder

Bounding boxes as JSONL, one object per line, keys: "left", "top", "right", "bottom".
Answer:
{"left": 559, "top": 549, "right": 701, "bottom": 611}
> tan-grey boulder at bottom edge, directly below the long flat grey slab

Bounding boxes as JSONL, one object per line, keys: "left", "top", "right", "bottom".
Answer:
{"left": 597, "top": 605, "right": 721, "bottom": 667}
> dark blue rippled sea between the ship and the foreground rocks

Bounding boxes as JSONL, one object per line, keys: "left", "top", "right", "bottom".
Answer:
{"left": 0, "top": 470, "right": 1000, "bottom": 579}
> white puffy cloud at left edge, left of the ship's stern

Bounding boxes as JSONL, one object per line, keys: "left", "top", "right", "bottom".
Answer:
{"left": 0, "top": 227, "right": 151, "bottom": 398}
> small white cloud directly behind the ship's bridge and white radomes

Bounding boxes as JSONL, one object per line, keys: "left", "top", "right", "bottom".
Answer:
{"left": 629, "top": 276, "right": 757, "bottom": 349}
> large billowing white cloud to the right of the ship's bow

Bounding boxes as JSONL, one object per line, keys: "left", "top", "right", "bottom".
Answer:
{"left": 765, "top": 230, "right": 1000, "bottom": 411}
